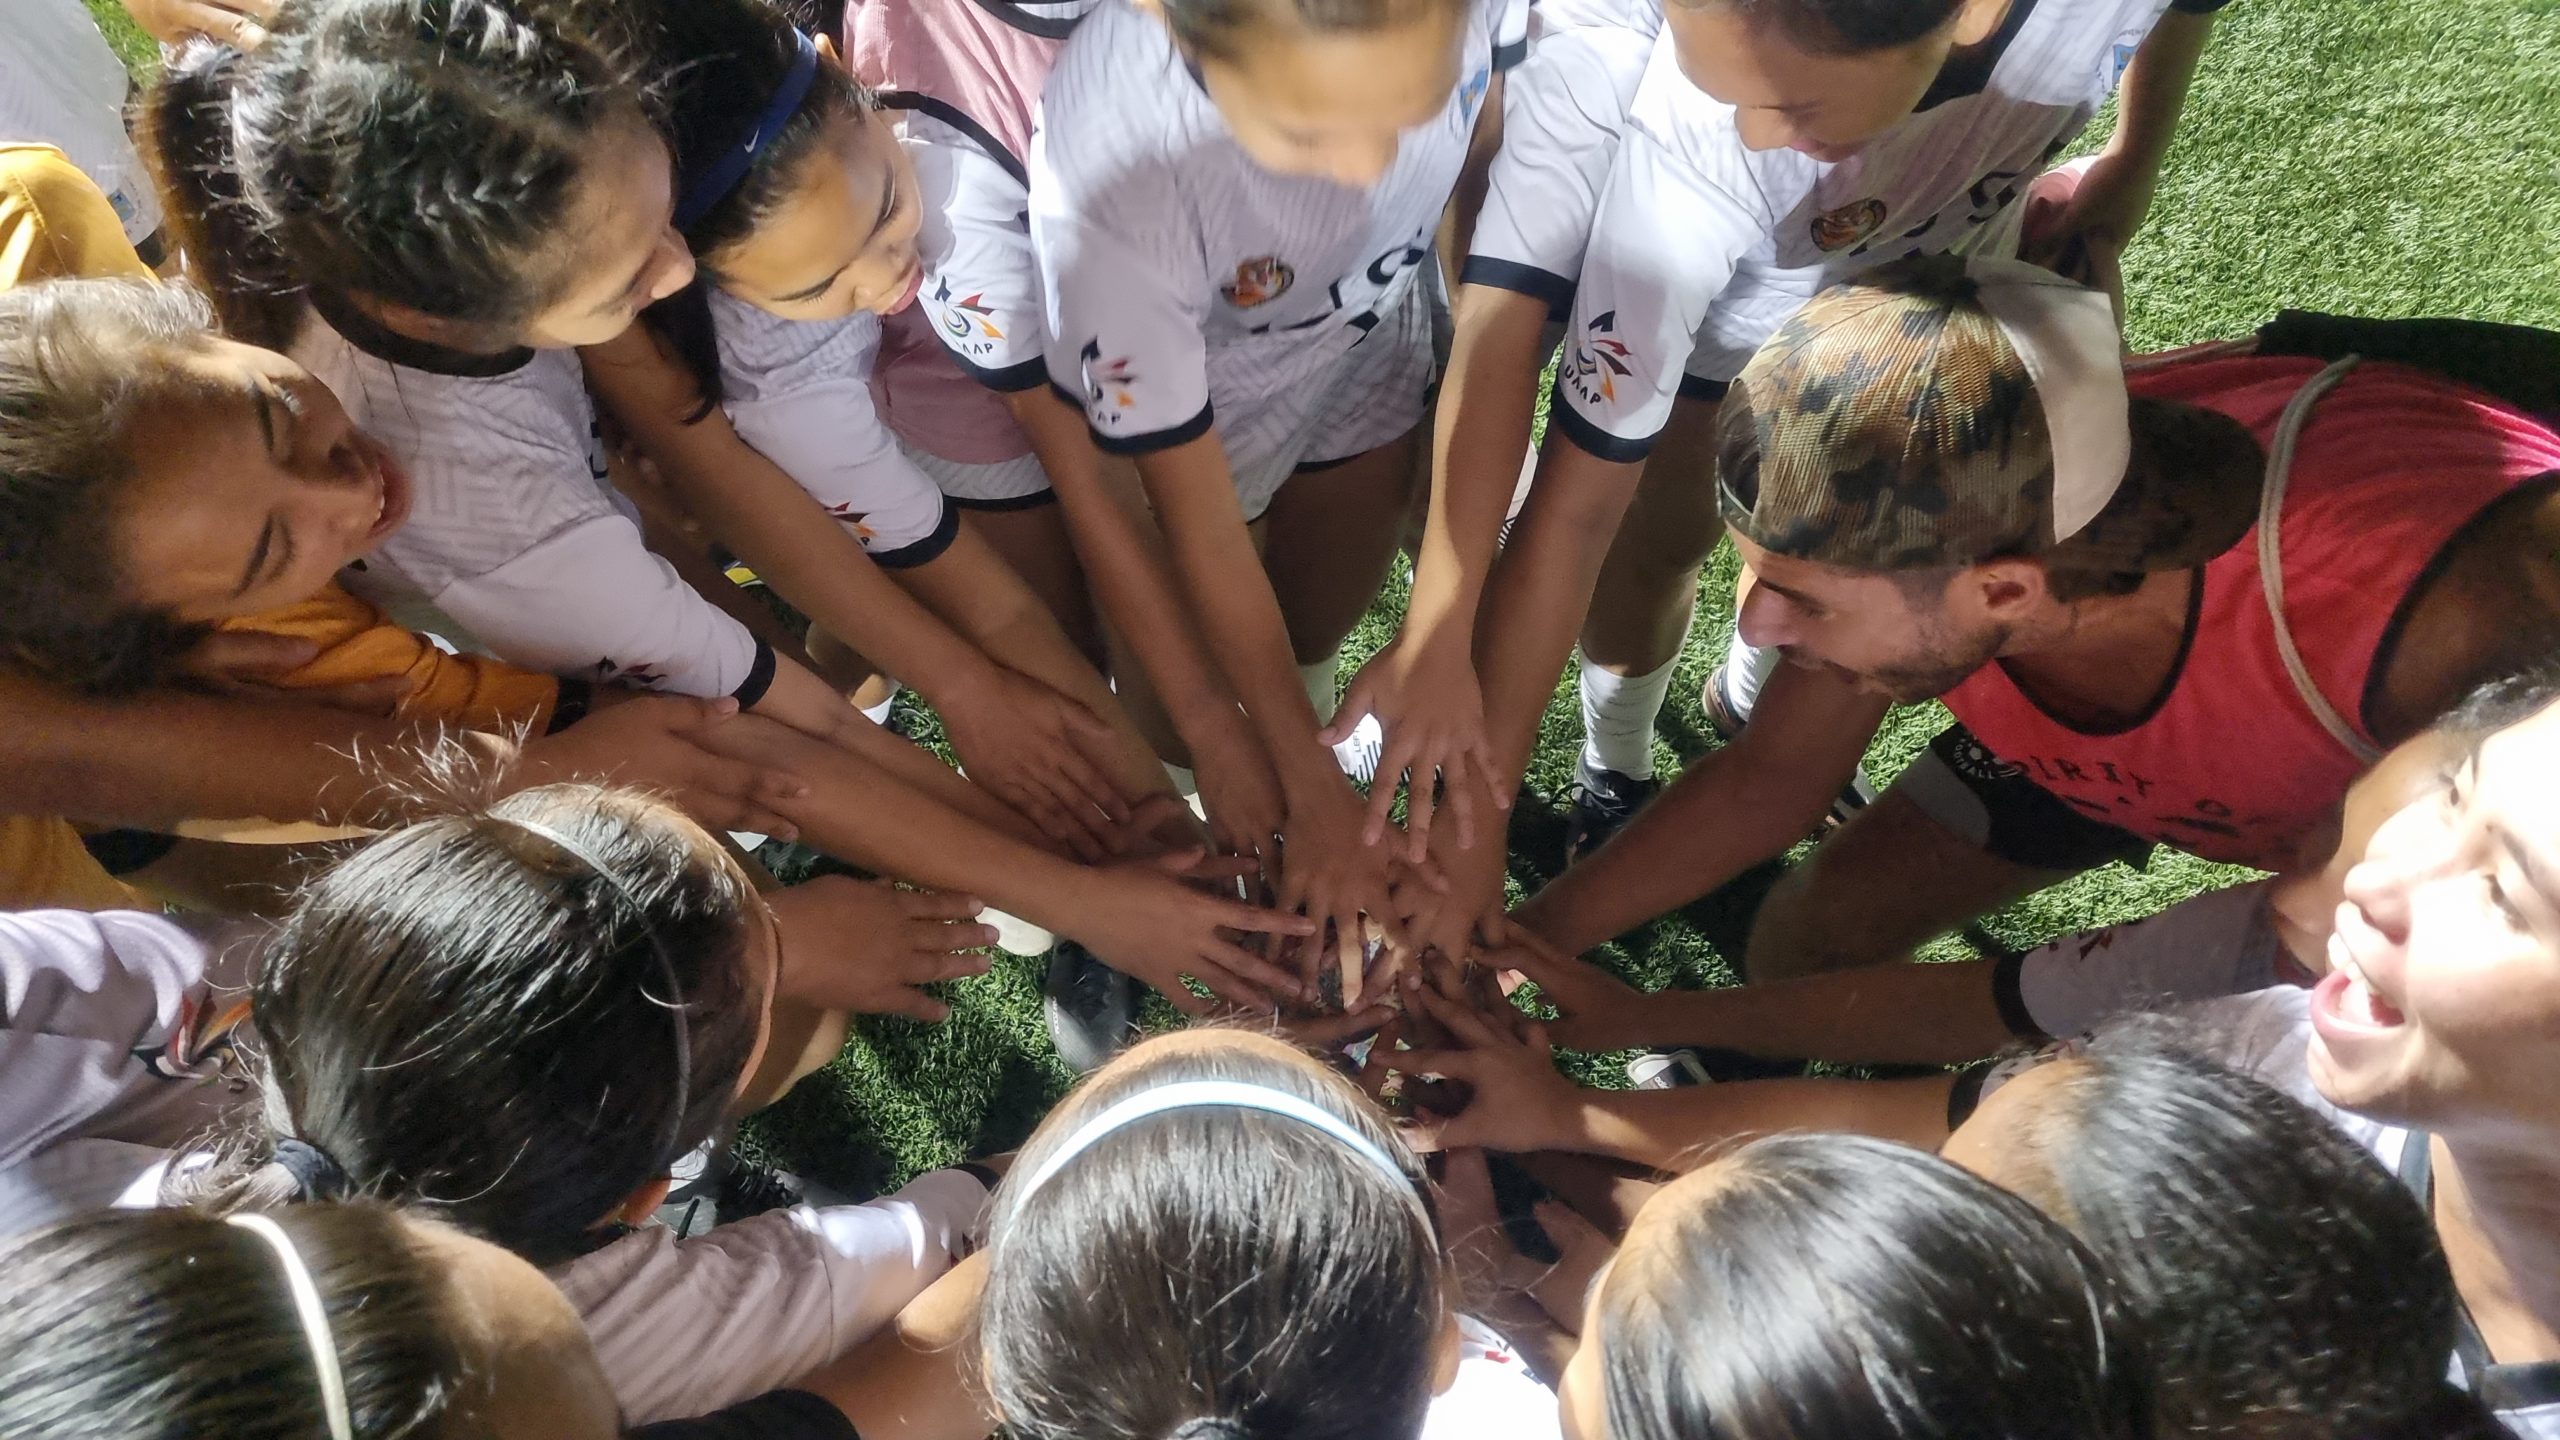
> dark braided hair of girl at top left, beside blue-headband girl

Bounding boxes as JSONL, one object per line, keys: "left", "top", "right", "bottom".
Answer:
{"left": 146, "top": 0, "right": 648, "bottom": 348}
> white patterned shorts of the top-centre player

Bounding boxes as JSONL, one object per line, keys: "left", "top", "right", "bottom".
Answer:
{"left": 1219, "top": 264, "right": 1449, "bottom": 520}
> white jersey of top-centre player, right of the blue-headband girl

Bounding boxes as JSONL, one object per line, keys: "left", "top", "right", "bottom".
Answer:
{"left": 1029, "top": 0, "right": 1526, "bottom": 469}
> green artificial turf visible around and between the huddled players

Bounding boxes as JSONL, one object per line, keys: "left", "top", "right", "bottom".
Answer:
{"left": 87, "top": 0, "right": 2560, "bottom": 1189}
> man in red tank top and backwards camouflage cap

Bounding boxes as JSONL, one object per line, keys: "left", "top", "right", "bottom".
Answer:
{"left": 1521, "top": 256, "right": 2560, "bottom": 981}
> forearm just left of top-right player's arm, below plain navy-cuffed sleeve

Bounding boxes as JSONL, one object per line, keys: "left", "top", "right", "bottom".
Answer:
{"left": 1405, "top": 284, "right": 1546, "bottom": 666}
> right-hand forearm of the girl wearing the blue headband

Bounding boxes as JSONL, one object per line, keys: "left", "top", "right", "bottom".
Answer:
{"left": 1009, "top": 389, "right": 1239, "bottom": 746}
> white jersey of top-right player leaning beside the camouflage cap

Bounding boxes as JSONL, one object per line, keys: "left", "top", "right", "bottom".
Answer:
{"left": 1554, "top": 0, "right": 2168, "bottom": 461}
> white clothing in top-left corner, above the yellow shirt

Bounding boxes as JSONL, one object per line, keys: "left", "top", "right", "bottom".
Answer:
{"left": 0, "top": 0, "right": 161, "bottom": 246}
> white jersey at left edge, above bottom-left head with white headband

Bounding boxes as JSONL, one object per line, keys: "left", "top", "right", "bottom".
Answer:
{"left": 0, "top": 910, "right": 261, "bottom": 1235}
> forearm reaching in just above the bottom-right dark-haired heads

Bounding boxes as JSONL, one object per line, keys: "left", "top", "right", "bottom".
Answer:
{"left": 1562, "top": 1076, "right": 1956, "bottom": 1174}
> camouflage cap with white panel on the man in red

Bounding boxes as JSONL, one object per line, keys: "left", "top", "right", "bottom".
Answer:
{"left": 1718, "top": 256, "right": 2258, "bottom": 571}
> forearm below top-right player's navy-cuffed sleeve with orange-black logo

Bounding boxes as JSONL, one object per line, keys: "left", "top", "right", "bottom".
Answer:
{"left": 1475, "top": 438, "right": 1641, "bottom": 784}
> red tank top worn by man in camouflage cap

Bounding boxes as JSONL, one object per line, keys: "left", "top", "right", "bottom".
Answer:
{"left": 1946, "top": 356, "right": 2560, "bottom": 871}
